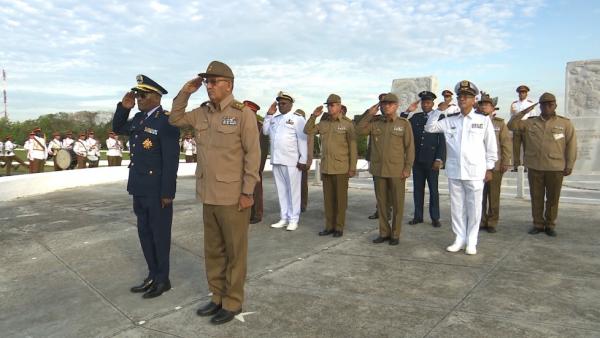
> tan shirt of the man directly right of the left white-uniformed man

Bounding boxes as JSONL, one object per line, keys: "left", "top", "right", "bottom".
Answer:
{"left": 304, "top": 115, "right": 358, "bottom": 175}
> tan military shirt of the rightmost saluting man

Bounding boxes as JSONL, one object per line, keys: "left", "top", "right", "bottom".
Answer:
{"left": 508, "top": 113, "right": 577, "bottom": 171}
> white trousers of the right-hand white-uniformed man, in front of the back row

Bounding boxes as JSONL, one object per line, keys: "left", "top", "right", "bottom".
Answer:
{"left": 448, "top": 178, "right": 484, "bottom": 247}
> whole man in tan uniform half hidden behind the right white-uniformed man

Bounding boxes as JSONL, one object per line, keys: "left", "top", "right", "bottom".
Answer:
{"left": 479, "top": 95, "right": 512, "bottom": 233}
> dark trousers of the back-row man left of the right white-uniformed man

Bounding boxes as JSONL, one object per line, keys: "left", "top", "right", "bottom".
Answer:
{"left": 413, "top": 162, "right": 440, "bottom": 220}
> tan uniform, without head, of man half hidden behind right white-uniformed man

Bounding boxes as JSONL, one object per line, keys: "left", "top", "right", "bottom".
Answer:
{"left": 480, "top": 116, "right": 512, "bottom": 228}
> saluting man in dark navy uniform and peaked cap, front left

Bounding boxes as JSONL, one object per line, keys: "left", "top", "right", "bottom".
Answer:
{"left": 112, "top": 75, "right": 179, "bottom": 298}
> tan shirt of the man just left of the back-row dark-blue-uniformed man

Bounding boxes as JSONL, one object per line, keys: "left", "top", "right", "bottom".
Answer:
{"left": 356, "top": 113, "right": 415, "bottom": 177}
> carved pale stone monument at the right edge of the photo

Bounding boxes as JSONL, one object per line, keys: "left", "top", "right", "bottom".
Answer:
{"left": 565, "top": 59, "right": 600, "bottom": 172}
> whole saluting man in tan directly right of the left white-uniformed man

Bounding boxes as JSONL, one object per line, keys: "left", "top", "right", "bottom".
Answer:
{"left": 304, "top": 94, "right": 357, "bottom": 237}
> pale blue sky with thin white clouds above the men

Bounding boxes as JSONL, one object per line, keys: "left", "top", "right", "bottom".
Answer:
{"left": 0, "top": 0, "right": 600, "bottom": 120}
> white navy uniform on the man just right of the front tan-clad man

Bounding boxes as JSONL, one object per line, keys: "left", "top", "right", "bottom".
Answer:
{"left": 262, "top": 112, "right": 307, "bottom": 224}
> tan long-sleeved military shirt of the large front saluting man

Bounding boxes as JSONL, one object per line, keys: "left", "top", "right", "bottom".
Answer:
{"left": 169, "top": 92, "right": 260, "bottom": 205}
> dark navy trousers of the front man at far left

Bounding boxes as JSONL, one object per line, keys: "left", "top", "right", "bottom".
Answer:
{"left": 133, "top": 196, "right": 173, "bottom": 283}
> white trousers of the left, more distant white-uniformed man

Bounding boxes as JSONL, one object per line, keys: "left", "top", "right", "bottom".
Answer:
{"left": 273, "top": 164, "right": 302, "bottom": 223}
